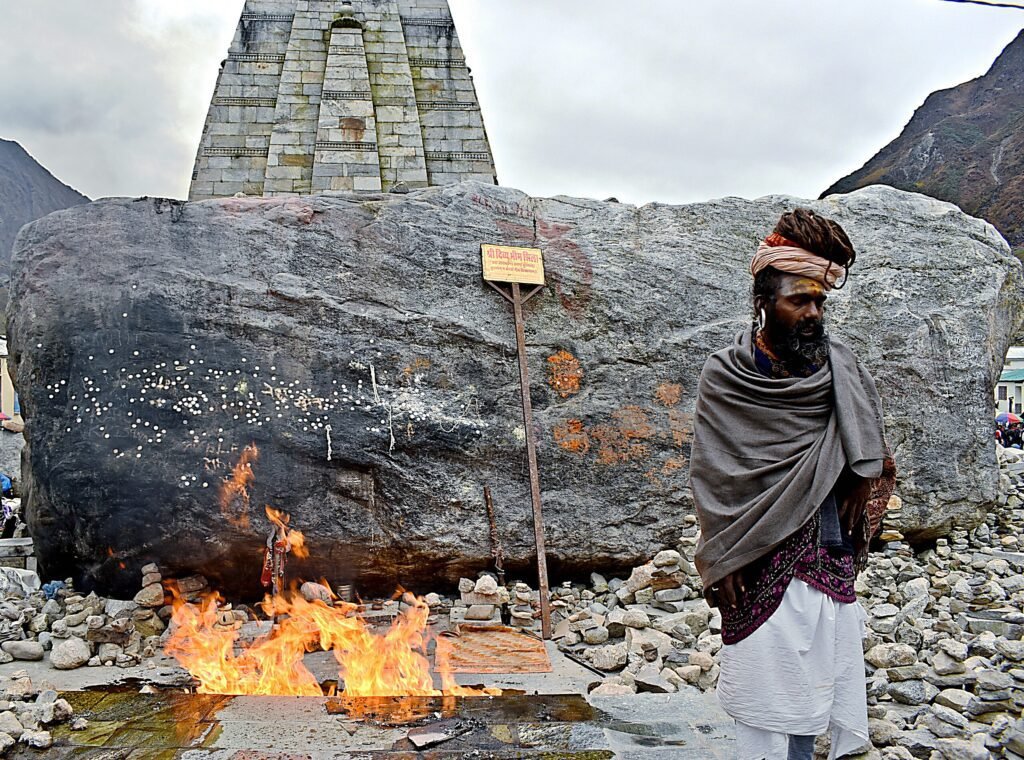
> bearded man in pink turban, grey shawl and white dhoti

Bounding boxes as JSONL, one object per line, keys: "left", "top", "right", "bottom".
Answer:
{"left": 690, "top": 209, "right": 895, "bottom": 760}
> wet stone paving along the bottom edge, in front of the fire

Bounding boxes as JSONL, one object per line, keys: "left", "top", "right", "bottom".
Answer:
{"left": 14, "top": 691, "right": 732, "bottom": 760}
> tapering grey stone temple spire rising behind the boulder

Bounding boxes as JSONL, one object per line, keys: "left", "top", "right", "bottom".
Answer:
{"left": 188, "top": 0, "right": 498, "bottom": 200}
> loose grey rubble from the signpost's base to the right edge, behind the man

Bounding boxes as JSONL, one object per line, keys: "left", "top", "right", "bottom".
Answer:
{"left": 438, "top": 452, "right": 1024, "bottom": 760}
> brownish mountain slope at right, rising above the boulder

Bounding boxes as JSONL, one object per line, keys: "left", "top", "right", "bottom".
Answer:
{"left": 821, "top": 30, "right": 1024, "bottom": 251}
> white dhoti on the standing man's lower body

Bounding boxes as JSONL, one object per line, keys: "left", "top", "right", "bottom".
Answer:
{"left": 718, "top": 578, "right": 868, "bottom": 760}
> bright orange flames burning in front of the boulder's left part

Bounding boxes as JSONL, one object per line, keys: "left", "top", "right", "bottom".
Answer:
{"left": 165, "top": 447, "right": 501, "bottom": 696}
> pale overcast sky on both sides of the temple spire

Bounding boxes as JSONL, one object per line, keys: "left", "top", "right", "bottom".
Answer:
{"left": 0, "top": 0, "right": 1024, "bottom": 203}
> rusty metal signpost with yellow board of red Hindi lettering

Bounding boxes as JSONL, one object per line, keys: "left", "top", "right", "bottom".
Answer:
{"left": 480, "top": 245, "right": 551, "bottom": 639}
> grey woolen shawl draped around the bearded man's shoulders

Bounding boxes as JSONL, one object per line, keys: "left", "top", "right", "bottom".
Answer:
{"left": 690, "top": 330, "right": 887, "bottom": 588}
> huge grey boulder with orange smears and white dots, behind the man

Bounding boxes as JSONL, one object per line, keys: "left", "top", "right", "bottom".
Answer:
{"left": 10, "top": 183, "right": 1024, "bottom": 593}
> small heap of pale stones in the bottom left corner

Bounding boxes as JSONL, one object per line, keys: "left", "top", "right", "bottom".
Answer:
{"left": 0, "top": 670, "right": 78, "bottom": 755}
